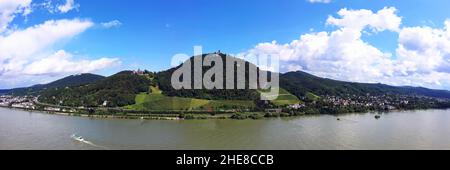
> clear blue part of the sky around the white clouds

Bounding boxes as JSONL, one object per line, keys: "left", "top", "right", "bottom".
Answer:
{"left": 0, "top": 0, "right": 450, "bottom": 89}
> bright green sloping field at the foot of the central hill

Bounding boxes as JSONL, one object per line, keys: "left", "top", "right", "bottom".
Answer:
{"left": 125, "top": 87, "right": 255, "bottom": 111}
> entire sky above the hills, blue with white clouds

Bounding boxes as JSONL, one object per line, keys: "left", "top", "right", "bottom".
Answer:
{"left": 0, "top": 0, "right": 450, "bottom": 90}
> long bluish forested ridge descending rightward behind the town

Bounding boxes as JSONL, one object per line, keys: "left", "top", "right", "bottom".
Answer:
{"left": 280, "top": 71, "right": 450, "bottom": 99}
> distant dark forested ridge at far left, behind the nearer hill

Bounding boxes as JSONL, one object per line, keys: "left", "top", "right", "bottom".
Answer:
{"left": 0, "top": 73, "right": 105, "bottom": 95}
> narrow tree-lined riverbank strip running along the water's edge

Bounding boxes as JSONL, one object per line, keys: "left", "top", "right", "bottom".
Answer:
{"left": 0, "top": 93, "right": 450, "bottom": 120}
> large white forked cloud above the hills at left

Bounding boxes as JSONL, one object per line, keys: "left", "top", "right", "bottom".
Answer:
{"left": 0, "top": 19, "right": 119, "bottom": 86}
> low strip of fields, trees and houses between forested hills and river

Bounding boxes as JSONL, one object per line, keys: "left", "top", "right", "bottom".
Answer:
{"left": 0, "top": 89, "right": 450, "bottom": 120}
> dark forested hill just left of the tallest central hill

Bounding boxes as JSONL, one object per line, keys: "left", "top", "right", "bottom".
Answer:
{"left": 39, "top": 71, "right": 152, "bottom": 107}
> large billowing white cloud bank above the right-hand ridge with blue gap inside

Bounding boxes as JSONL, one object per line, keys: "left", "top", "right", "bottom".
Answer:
{"left": 241, "top": 8, "right": 450, "bottom": 89}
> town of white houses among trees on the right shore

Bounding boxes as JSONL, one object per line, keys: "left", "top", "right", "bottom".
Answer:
{"left": 283, "top": 94, "right": 450, "bottom": 114}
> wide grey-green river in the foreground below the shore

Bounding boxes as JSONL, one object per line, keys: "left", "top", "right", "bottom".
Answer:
{"left": 0, "top": 108, "right": 450, "bottom": 150}
